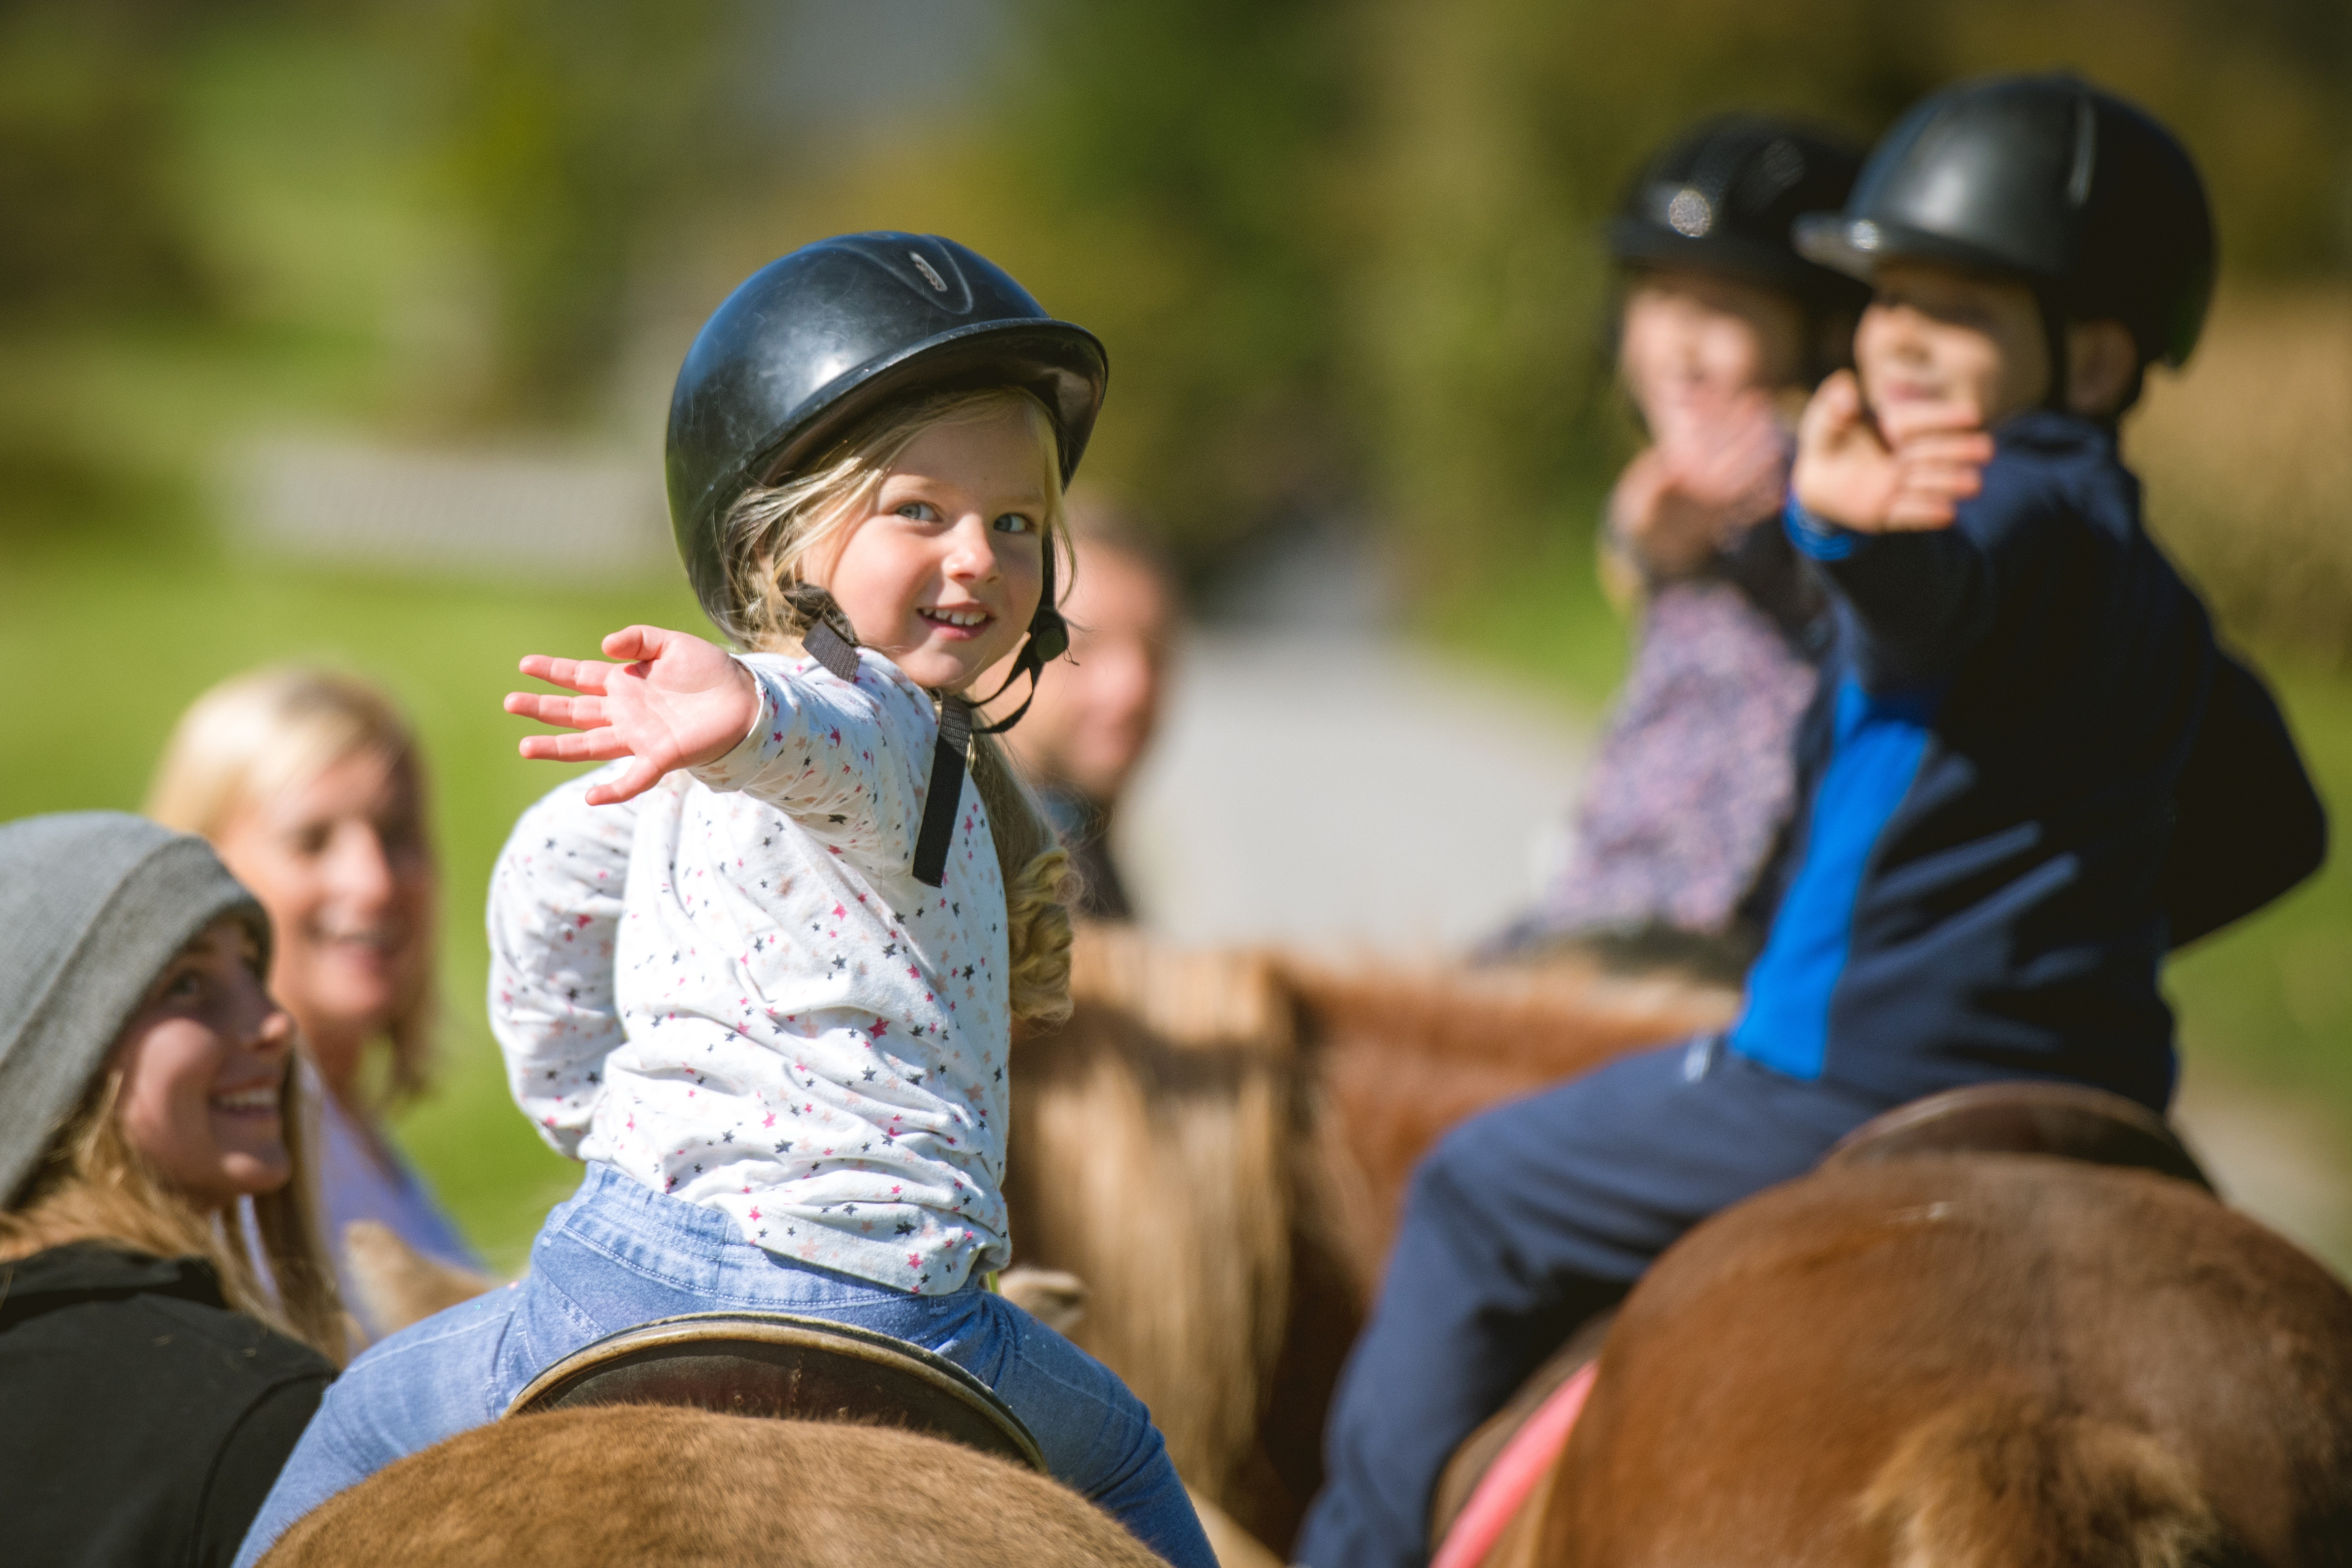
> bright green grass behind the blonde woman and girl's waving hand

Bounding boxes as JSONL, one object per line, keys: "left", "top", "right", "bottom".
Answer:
{"left": 0, "top": 555, "right": 701, "bottom": 1267}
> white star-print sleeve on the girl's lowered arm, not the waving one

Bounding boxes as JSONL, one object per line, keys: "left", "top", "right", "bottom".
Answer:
{"left": 489, "top": 760, "right": 637, "bottom": 1159}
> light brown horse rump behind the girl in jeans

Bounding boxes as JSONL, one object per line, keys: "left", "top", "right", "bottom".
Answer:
{"left": 263, "top": 1406, "right": 1160, "bottom": 1568}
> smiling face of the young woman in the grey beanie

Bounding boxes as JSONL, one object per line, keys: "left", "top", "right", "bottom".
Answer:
{"left": 108, "top": 914, "right": 294, "bottom": 1208}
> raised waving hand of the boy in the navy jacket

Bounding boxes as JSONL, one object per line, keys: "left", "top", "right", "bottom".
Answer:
{"left": 1790, "top": 372, "right": 1992, "bottom": 534}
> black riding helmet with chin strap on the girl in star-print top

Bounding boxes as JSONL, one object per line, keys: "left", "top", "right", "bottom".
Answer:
{"left": 666, "top": 230, "right": 1110, "bottom": 886}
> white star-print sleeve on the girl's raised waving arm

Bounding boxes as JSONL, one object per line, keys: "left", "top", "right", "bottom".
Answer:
{"left": 694, "top": 656, "right": 938, "bottom": 872}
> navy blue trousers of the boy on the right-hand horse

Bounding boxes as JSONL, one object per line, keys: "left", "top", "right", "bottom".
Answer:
{"left": 1291, "top": 1037, "right": 1886, "bottom": 1568}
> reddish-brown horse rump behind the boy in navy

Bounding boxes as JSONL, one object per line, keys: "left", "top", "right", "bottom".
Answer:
{"left": 1538, "top": 1154, "right": 2352, "bottom": 1568}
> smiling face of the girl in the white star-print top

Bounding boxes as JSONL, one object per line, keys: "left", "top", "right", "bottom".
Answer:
{"left": 814, "top": 407, "right": 1054, "bottom": 691}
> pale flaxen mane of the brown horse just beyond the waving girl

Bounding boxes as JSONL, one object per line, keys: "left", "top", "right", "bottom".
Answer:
{"left": 1007, "top": 931, "right": 1291, "bottom": 1497}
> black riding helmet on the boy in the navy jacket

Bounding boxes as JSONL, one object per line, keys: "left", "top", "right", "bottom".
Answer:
{"left": 1797, "top": 73, "right": 2216, "bottom": 380}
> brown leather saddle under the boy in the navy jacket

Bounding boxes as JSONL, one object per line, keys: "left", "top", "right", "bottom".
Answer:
{"left": 1818, "top": 1081, "right": 2213, "bottom": 1192}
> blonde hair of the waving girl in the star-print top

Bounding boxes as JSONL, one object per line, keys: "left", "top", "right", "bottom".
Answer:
{"left": 706, "top": 386, "right": 1077, "bottom": 1022}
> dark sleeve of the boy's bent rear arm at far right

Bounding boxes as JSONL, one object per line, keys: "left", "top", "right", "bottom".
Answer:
{"left": 2161, "top": 654, "right": 2328, "bottom": 947}
